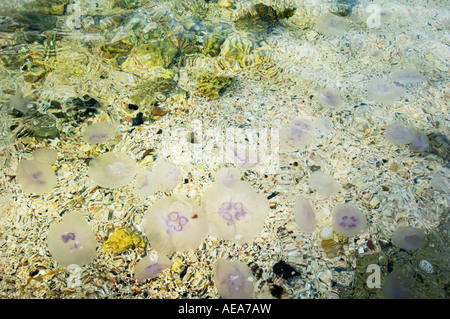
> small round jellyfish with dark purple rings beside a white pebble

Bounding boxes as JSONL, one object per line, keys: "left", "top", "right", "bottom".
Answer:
{"left": 331, "top": 204, "right": 367, "bottom": 237}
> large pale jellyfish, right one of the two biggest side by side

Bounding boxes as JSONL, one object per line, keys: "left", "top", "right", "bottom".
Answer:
{"left": 202, "top": 169, "right": 269, "bottom": 244}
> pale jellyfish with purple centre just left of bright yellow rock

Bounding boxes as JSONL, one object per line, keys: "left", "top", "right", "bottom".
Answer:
{"left": 47, "top": 211, "right": 97, "bottom": 267}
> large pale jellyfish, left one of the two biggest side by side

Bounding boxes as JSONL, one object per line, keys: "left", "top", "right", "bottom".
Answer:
{"left": 140, "top": 194, "right": 208, "bottom": 255}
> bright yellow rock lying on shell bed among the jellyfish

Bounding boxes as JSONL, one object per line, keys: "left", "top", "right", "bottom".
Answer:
{"left": 103, "top": 228, "right": 146, "bottom": 254}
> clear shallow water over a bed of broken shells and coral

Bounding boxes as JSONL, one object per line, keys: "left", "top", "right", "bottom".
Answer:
{"left": 0, "top": 0, "right": 450, "bottom": 299}
